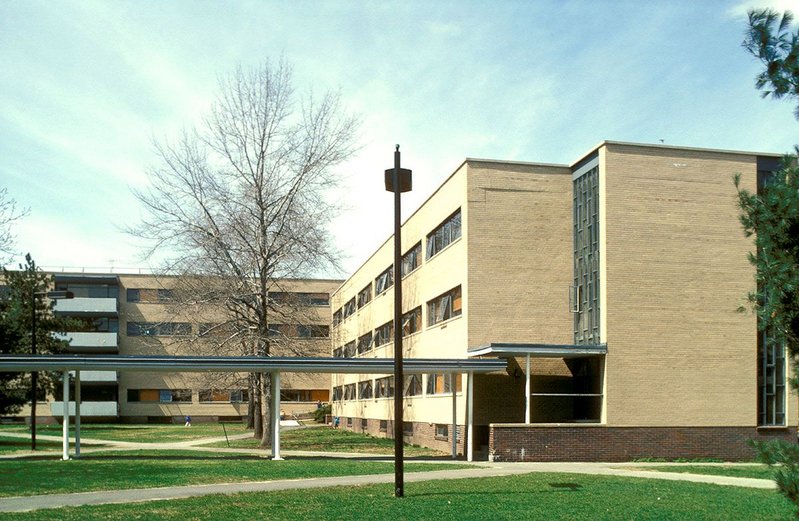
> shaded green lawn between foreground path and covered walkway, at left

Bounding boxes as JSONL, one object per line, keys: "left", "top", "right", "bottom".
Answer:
{"left": 0, "top": 450, "right": 464, "bottom": 497}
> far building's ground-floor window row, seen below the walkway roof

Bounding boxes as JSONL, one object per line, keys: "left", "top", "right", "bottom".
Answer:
{"left": 128, "top": 389, "right": 328, "bottom": 403}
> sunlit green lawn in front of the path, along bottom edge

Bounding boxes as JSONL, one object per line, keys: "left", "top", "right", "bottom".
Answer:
{"left": 0, "top": 473, "right": 793, "bottom": 521}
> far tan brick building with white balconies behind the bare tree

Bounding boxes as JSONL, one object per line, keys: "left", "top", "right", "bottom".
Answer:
{"left": 20, "top": 272, "right": 341, "bottom": 422}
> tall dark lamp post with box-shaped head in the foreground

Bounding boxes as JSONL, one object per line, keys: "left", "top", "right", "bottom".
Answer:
{"left": 385, "top": 145, "right": 411, "bottom": 497}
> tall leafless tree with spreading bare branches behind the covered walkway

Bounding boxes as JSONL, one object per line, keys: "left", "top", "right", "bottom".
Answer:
{"left": 129, "top": 60, "right": 358, "bottom": 445}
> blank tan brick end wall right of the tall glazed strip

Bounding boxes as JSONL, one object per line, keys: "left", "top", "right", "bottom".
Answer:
{"left": 600, "top": 144, "right": 796, "bottom": 426}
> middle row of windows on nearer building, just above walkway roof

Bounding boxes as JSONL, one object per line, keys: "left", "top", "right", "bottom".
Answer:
{"left": 333, "top": 286, "right": 463, "bottom": 358}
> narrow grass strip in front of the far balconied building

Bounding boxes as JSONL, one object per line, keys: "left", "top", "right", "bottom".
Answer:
{"left": 0, "top": 422, "right": 252, "bottom": 443}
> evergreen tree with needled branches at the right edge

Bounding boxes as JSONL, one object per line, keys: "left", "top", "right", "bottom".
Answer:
{"left": 735, "top": 9, "right": 799, "bottom": 515}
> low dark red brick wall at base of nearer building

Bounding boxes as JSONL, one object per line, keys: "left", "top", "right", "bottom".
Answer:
{"left": 489, "top": 424, "right": 797, "bottom": 461}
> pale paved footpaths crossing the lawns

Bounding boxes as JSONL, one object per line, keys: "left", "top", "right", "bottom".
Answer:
{"left": 0, "top": 433, "right": 775, "bottom": 512}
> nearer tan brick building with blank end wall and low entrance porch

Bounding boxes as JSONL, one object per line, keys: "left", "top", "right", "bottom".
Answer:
{"left": 331, "top": 142, "right": 797, "bottom": 460}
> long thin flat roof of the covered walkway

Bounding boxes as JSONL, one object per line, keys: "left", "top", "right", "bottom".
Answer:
{"left": 0, "top": 355, "right": 507, "bottom": 374}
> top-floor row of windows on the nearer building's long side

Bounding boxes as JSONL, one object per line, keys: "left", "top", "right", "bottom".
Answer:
{"left": 333, "top": 208, "right": 461, "bottom": 320}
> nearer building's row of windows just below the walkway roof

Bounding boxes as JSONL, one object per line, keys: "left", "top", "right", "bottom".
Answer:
{"left": 333, "top": 373, "right": 461, "bottom": 401}
